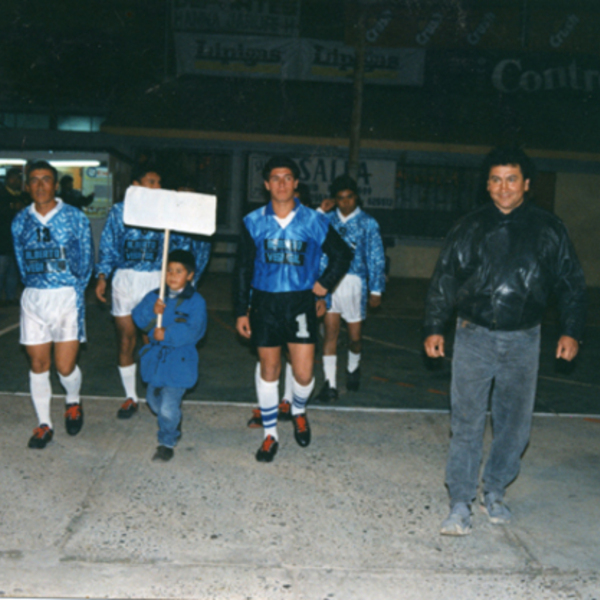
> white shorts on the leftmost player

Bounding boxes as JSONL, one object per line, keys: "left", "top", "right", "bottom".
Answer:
{"left": 20, "top": 287, "right": 79, "bottom": 346}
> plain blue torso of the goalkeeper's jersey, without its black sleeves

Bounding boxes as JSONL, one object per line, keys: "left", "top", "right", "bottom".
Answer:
{"left": 244, "top": 200, "right": 329, "bottom": 293}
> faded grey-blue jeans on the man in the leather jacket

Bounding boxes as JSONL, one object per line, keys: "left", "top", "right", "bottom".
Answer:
{"left": 446, "top": 319, "right": 540, "bottom": 505}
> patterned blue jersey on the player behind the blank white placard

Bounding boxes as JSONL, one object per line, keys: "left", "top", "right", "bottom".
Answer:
{"left": 96, "top": 202, "right": 210, "bottom": 283}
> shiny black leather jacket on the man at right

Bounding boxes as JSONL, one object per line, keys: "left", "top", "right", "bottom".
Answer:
{"left": 425, "top": 202, "right": 586, "bottom": 341}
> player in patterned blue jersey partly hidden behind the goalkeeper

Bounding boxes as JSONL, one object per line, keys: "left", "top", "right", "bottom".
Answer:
{"left": 317, "top": 175, "right": 385, "bottom": 402}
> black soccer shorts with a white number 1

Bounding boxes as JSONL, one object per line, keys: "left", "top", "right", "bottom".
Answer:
{"left": 250, "top": 289, "right": 319, "bottom": 348}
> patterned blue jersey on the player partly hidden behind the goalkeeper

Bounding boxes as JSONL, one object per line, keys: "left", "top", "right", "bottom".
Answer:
{"left": 321, "top": 208, "right": 385, "bottom": 319}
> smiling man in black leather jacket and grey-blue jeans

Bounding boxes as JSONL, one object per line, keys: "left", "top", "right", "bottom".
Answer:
{"left": 425, "top": 148, "right": 585, "bottom": 535}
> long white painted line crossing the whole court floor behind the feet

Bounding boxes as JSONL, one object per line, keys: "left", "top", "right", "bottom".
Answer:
{"left": 0, "top": 392, "right": 600, "bottom": 420}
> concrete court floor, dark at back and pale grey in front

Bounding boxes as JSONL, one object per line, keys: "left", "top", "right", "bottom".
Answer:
{"left": 0, "top": 276, "right": 600, "bottom": 600}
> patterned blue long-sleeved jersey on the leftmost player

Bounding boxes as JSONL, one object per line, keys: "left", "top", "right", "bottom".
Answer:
{"left": 12, "top": 198, "right": 94, "bottom": 341}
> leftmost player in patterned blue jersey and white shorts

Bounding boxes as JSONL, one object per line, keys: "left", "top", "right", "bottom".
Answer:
{"left": 12, "top": 161, "right": 94, "bottom": 449}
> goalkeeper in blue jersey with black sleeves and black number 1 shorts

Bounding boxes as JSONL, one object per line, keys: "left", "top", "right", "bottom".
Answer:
{"left": 235, "top": 156, "right": 352, "bottom": 462}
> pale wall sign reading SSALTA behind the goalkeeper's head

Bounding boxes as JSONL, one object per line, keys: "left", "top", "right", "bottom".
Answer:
{"left": 248, "top": 154, "right": 396, "bottom": 209}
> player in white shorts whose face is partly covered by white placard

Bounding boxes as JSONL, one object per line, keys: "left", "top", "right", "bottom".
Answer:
{"left": 96, "top": 163, "right": 210, "bottom": 419}
